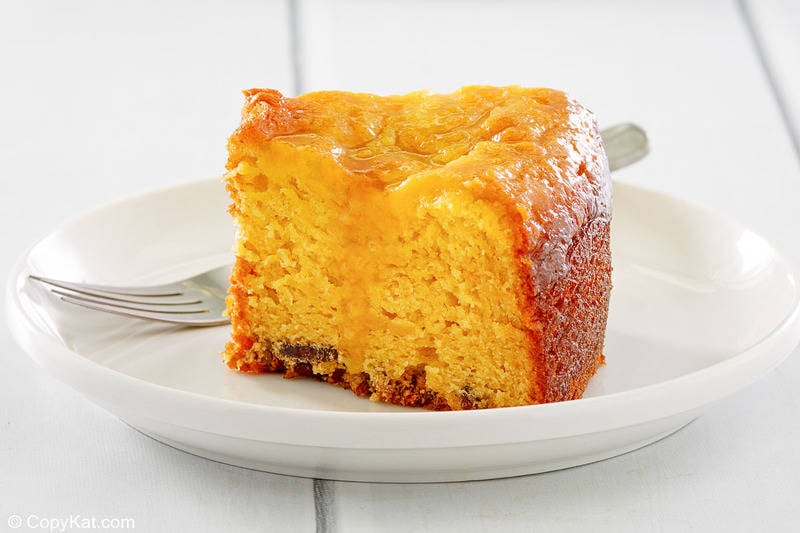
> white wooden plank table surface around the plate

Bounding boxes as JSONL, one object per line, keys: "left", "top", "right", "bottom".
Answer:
{"left": 0, "top": 0, "right": 800, "bottom": 532}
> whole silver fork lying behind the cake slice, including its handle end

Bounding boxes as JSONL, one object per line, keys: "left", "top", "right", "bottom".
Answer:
{"left": 30, "top": 124, "right": 649, "bottom": 326}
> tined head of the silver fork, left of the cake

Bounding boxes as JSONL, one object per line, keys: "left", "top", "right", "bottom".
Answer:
{"left": 29, "top": 265, "right": 231, "bottom": 326}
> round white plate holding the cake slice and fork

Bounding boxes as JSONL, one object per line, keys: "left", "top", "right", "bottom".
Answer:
{"left": 7, "top": 180, "right": 800, "bottom": 482}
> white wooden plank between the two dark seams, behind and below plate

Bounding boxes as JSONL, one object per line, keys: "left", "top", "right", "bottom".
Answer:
{"left": 300, "top": 0, "right": 800, "bottom": 532}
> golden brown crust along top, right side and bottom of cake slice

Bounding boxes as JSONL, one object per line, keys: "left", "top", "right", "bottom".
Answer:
{"left": 226, "top": 87, "right": 611, "bottom": 410}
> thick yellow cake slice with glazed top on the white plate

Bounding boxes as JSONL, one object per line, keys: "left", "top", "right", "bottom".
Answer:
{"left": 224, "top": 86, "right": 611, "bottom": 410}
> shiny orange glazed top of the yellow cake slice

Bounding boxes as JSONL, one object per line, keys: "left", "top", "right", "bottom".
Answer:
{"left": 228, "top": 86, "right": 611, "bottom": 284}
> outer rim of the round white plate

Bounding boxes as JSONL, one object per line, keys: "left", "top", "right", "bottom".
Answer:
{"left": 5, "top": 178, "right": 800, "bottom": 449}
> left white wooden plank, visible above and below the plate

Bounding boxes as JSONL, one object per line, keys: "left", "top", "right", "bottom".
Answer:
{"left": 0, "top": 0, "right": 315, "bottom": 532}
